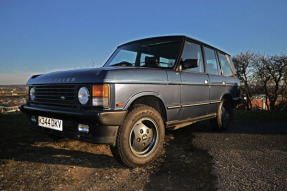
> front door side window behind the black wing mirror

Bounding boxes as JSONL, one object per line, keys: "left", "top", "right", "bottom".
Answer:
{"left": 181, "top": 42, "right": 204, "bottom": 72}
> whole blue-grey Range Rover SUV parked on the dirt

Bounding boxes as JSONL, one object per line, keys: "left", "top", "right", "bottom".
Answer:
{"left": 20, "top": 36, "right": 240, "bottom": 167}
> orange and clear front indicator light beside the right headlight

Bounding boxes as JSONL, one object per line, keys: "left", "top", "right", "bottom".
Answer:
{"left": 93, "top": 84, "right": 110, "bottom": 108}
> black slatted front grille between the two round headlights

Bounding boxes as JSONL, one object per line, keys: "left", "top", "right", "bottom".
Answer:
{"left": 30, "top": 85, "right": 77, "bottom": 108}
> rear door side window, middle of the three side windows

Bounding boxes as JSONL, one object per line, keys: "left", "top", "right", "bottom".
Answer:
{"left": 204, "top": 47, "right": 221, "bottom": 75}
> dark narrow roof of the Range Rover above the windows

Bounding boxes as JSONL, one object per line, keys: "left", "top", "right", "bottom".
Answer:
{"left": 118, "top": 35, "right": 230, "bottom": 56}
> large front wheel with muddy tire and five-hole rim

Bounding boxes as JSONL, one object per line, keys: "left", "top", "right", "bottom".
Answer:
{"left": 111, "top": 105, "right": 165, "bottom": 167}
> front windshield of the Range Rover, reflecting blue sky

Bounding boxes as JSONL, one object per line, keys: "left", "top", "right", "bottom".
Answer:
{"left": 104, "top": 39, "right": 181, "bottom": 68}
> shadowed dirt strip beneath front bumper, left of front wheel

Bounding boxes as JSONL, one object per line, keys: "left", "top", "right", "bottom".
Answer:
{"left": 0, "top": 133, "right": 127, "bottom": 169}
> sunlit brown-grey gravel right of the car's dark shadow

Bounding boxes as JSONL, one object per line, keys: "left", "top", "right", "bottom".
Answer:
{"left": 193, "top": 121, "right": 287, "bottom": 190}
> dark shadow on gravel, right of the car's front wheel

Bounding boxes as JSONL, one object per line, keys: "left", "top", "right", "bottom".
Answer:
{"left": 145, "top": 124, "right": 217, "bottom": 190}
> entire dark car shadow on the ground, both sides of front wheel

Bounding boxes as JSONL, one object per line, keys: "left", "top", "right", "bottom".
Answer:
{"left": 1, "top": 121, "right": 219, "bottom": 190}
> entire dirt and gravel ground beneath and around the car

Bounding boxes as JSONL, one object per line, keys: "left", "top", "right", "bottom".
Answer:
{"left": 0, "top": 118, "right": 287, "bottom": 190}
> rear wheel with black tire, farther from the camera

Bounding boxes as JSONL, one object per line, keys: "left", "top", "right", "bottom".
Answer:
{"left": 210, "top": 99, "right": 232, "bottom": 131}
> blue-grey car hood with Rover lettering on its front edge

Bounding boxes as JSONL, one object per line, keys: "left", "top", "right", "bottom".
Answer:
{"left": 27, "top": 67, "right": 167, "bottom": 85}
